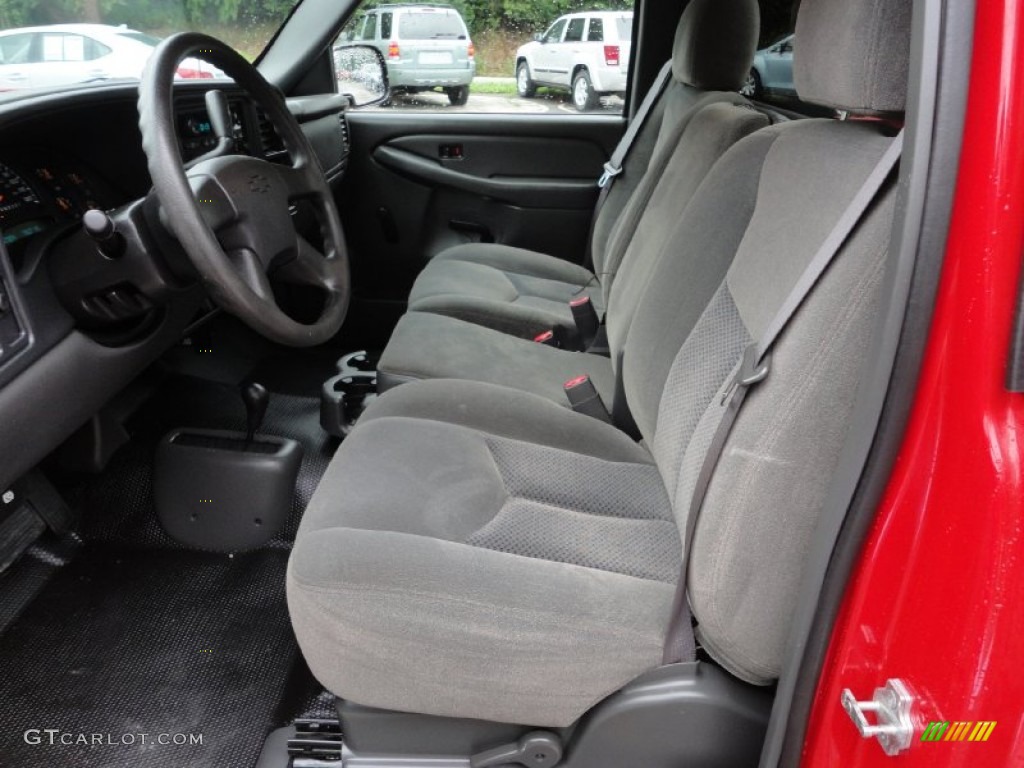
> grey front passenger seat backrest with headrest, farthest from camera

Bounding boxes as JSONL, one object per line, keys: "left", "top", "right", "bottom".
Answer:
{"left": 591, "top": 0, "right": 761, "bottom": 298}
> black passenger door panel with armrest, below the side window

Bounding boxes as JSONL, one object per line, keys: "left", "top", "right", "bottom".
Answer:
{"left": 340, "top": 111, "right": 623, "bottom": 300}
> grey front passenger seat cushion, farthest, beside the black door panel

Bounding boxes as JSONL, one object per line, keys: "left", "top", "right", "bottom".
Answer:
{"left": 409, "top": 243, "right": 603, "bottom": 338}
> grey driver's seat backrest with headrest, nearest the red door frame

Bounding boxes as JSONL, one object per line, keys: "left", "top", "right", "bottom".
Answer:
{"left": 609, "top": 0, "right": 911, "bottom": 683}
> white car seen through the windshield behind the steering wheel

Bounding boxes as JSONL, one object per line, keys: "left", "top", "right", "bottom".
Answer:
{"left": 0, "top": 24, "right": 222, "bottom": 90}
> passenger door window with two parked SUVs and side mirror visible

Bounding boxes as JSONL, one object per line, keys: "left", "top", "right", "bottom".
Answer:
{"left": 331, "top": 0, "right": 634, "bottom": 117}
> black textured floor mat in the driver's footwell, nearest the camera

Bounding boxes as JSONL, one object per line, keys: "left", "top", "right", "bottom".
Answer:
{"left": 0, "top": 546, "right": 315, "bottom": 768}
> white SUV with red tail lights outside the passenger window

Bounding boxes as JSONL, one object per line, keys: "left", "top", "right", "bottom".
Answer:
{"left": 515, "top": 10, "right": 633, "bottom": 112}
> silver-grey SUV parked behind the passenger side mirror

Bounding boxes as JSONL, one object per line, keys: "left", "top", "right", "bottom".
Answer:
{"left": 335, "top": 4, "right": 476, "bottom": 106}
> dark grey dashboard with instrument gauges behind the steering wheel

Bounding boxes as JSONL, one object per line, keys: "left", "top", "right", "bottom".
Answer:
{"left": 0, "top": 83, "right": 348, "bottom": 488}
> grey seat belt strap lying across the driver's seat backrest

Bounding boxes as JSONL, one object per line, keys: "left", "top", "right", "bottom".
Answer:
{"left": 663, "top": 131, "right": 903, "bottom": 664}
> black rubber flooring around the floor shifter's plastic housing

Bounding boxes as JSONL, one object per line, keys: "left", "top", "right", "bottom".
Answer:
{"left": 73, "top": 377, "right": 338, "bottom": 548}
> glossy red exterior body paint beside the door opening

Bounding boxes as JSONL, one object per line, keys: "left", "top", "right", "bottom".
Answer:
{"left": 803, "top": 0, "right": 1024, "bottom": 768}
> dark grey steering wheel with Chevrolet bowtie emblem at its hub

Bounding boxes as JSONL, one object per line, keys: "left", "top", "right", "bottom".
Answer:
{"left": 138, "top": 32, "right": 351, "bottom": 346}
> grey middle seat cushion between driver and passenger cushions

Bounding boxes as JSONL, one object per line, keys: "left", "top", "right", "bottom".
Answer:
{"left": 377, "top": 312, "right": 615, "bottom": 407}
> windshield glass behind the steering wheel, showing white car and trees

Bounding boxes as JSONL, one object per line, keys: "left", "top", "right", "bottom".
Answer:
{"left": 0, "top": 0, "right": 298, "bottom": 91}
